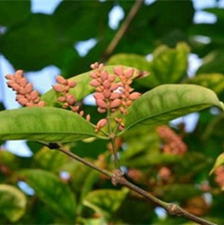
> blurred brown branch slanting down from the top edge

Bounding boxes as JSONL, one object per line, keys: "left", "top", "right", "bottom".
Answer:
{"left": 103, "top": 0, "right": 144, "bottom": 59}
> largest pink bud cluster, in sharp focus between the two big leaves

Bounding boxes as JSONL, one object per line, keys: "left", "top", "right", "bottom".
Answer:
{"left": 90, "top": 62, "right": 140, "bottom": 131}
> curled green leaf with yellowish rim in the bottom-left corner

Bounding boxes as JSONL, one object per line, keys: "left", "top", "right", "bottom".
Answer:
{"left": 0, "top": 184, "right": 26, "bottom": 222}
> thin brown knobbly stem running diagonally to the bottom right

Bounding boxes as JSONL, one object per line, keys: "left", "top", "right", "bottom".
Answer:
{"left": 42, "top": 143, "right": 217, "bottom": 225}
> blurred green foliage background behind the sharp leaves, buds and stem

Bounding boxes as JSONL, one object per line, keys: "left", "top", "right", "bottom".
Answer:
{"left": 0, "top": 0, "right": 224, "bottom": 225}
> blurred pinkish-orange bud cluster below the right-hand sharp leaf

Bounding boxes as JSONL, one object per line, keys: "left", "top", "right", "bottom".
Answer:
{"left": 156, "top": 125, "right": 187, "bottom": 155}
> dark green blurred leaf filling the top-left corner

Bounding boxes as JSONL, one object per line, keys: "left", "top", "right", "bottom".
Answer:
{"left": 0, "top": 0, "right": 31, "bottom": 26}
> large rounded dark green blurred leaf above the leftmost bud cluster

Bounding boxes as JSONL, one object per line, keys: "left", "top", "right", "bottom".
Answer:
{"left": 1, "top": 14, "right": 60, "bottom": 71}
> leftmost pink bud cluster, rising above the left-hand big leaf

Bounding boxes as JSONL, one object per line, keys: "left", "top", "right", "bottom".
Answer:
{"left": 5, "top": 70, "right": 45, "bottom": 107}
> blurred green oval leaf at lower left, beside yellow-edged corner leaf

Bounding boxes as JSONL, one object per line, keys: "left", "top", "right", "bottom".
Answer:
{"left": 21, "top": 169, "right": 76, "bottom": 223}
